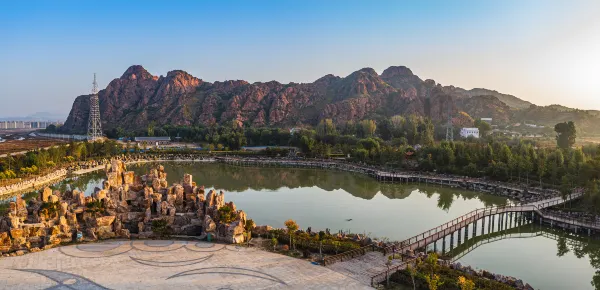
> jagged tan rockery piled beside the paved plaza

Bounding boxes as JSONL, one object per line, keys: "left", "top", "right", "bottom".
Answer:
{"left": 0, "top": 160, "right": 252, "bottom": 254}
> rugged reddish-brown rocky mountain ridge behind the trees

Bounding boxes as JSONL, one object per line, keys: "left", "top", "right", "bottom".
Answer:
{"left": 62, "top": 65, "right": 528, "bottom": 133}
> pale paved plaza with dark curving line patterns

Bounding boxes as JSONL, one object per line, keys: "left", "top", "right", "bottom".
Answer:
{"left": 0, "top": 240, "right": 370, "bottom": 290}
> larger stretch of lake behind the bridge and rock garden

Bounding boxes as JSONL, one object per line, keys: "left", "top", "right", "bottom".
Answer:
{"left": 3, "top": 162, "right": 509, "bottom": 240}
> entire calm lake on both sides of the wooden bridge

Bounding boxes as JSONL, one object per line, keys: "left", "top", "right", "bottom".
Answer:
{"left": 5, "top": 162, "right": 600, "bottom": 289}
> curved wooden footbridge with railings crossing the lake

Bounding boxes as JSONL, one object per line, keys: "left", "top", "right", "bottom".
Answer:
{"left": 324, "top": 192, "right": 600, "bottom": 286}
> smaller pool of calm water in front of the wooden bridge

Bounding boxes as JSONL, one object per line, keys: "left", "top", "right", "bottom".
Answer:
{"left": 452, "top": 224, "right": 600, "bottom": 290}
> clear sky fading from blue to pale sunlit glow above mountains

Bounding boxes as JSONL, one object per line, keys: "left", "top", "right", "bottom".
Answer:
{"left": 0, "top": 0, "right": 600, "bottom": 117}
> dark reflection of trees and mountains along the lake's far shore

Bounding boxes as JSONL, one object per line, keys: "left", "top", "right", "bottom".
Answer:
{"left": 129, "top": 163, "right": 506, "bottom": 210}
